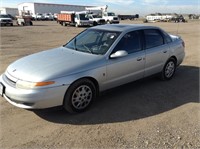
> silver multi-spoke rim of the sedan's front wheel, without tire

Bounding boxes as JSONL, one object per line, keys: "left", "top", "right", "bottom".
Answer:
{"left": 72, "top": 85, "right": 92, "bottom": 110}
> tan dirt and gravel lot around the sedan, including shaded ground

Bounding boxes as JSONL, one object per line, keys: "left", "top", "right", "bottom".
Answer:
{"left": 0, "top": 21, "right": 200, "bottom": 149}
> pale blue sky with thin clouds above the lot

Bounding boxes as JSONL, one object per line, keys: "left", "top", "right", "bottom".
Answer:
{"left": 0, "top": 0, "right": 200, "bottom": 15}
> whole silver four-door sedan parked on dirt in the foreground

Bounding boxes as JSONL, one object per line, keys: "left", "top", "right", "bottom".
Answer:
{"left": 0, "top": 24, "right": 185, "bottom": 113}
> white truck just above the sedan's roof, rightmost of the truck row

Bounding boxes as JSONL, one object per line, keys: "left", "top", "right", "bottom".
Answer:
{"left": 103, "top": 12, "right": 119, "bottom": 24}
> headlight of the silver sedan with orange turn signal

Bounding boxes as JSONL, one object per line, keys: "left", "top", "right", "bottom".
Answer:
{"left": 16, "top": 80, "right": 55, "bottom": 89}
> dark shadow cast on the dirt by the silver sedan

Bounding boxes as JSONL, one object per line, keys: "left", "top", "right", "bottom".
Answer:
{"left": 34, "top": 66, "right": 199, "bottom": 125}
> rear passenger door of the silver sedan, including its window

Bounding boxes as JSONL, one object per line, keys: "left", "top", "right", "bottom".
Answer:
{"left": 144, "top": 29, "right": 169, "bottom": 76}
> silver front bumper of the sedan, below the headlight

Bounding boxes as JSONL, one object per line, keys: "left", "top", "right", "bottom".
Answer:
{"left": 0, "top": 75, "right": 69, "bottom": 109}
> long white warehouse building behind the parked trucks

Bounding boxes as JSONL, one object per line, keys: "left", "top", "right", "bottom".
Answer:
{"left": 18, "top": 2, "right": 94, "bottom": 15}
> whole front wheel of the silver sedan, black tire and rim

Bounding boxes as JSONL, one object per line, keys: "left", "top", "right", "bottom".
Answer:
{"left": 63, "top": 79, "right": 97, "bottom": 113}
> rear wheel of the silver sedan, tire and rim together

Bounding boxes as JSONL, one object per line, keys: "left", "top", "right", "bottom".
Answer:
{"left": 160, "top": 58, "right": 176, "bottom": 80}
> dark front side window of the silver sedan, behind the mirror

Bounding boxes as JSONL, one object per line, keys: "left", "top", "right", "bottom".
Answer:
{"left": 114, "top": 31, "right": 142, "bottom": 53}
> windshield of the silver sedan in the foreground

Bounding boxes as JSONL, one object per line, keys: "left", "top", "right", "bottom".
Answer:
{"left": 64, "top": 29, "right": 120, "bottom": 55}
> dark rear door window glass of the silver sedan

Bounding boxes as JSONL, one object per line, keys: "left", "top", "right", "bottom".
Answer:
{"left": 144, "top": 29, "right": 164, "bottom": 49}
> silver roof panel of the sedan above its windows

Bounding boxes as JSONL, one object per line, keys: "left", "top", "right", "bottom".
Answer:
{"left": 92, "top": 24, "right": 160, "bottom": 32}
